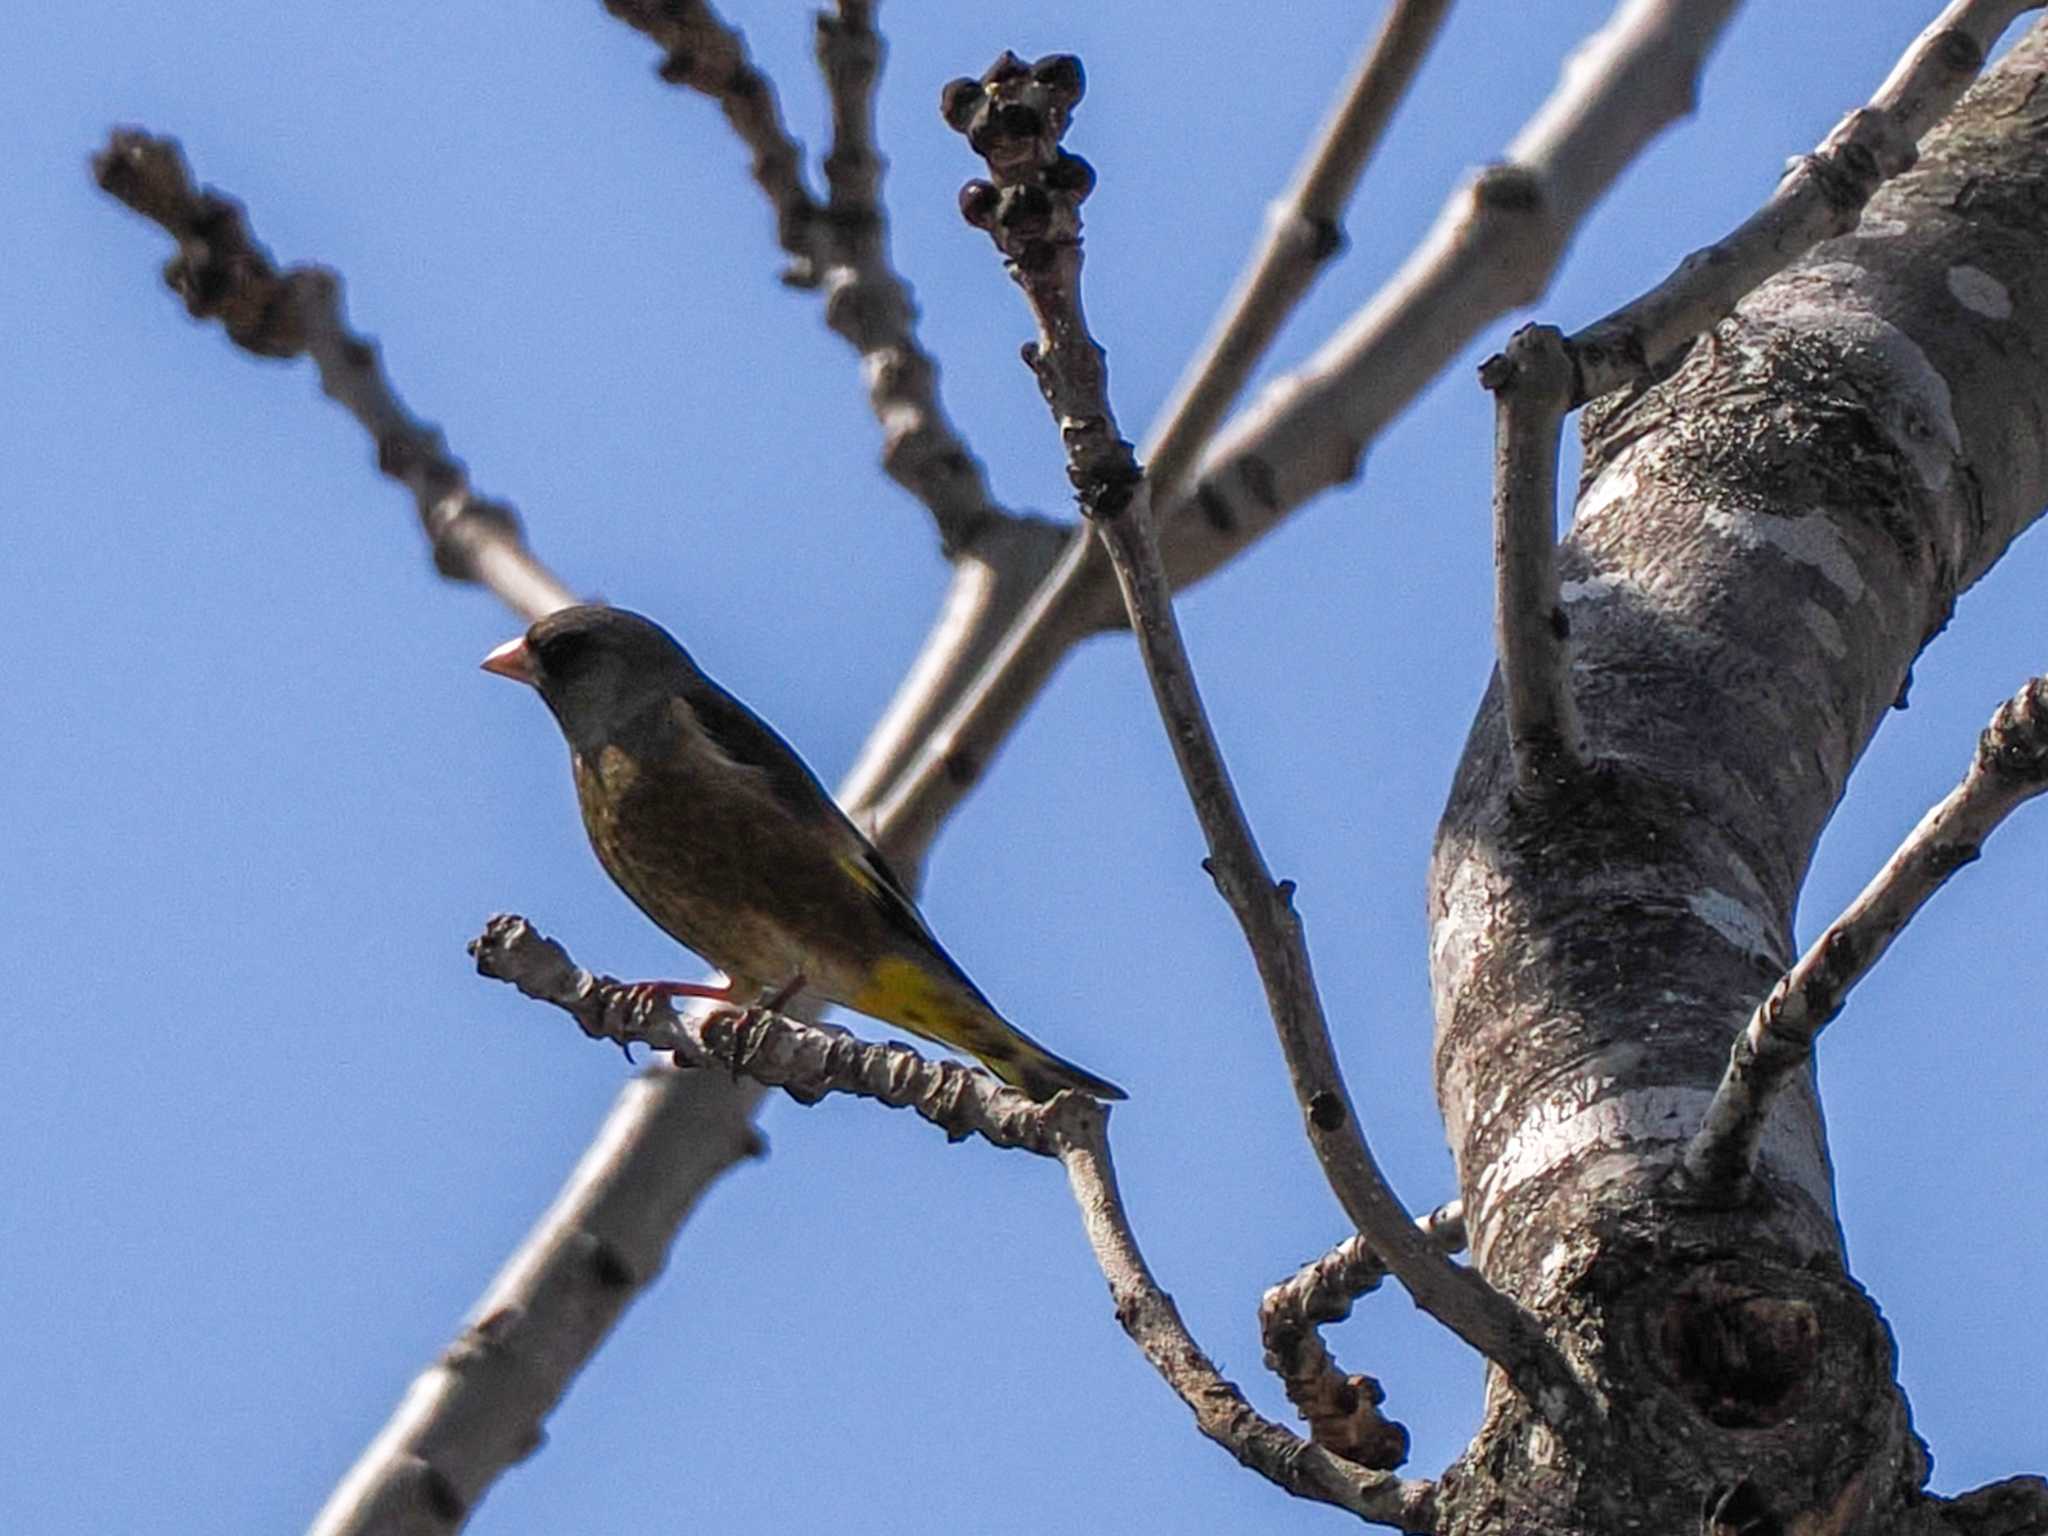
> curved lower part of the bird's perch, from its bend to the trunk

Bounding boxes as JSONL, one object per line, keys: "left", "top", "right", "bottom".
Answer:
{"left": 1051, "top": 1094, "right": 1436, "bottom": 1532}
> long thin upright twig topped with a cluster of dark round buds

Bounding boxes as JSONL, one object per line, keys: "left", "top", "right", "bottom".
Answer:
{"left": 942, "top": 53, "right": 1575, "bottom": 1411}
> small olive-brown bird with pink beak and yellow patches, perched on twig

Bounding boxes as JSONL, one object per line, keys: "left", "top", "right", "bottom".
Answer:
{"left": 483, "top": 604, "right": 1124, "bottom": 1100}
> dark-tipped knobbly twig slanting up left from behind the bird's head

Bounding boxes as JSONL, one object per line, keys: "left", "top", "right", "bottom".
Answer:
{"left": 92, "top": 129, "right": 575, "bottom": 618}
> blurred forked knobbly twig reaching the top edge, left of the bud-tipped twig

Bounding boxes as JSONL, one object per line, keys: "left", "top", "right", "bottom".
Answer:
{"left": 606, "top": 0, "right": 1034, "bottom": 559}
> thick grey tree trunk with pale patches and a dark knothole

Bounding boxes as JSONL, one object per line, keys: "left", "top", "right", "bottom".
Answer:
{"left": 1430, "top": 27, "right": 2048, "bottom": 1536}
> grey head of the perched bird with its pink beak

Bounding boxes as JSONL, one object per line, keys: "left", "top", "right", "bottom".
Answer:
{"left": 483, "top": 604, "right": 702, "bottom": 752}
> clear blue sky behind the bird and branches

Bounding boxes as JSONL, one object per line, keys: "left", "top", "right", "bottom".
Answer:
{"left": 0, "top": 0, "right": 2048, "bottom": 1536}
